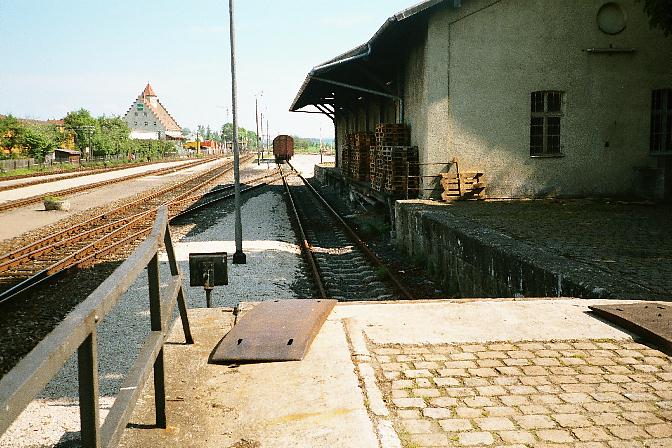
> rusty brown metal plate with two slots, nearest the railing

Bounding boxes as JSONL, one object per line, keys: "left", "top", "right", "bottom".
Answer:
{"left": 210, "top": 299, "right": 337, "bottom": 364}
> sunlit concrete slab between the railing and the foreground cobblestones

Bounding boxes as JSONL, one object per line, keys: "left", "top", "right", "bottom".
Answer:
{"left": 121, "top": 309, "right": 378, "bottom": 448}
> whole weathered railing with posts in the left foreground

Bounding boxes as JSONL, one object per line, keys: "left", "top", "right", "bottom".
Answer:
{"left": 0, "top": 206, "right": 194, "bottom": 448}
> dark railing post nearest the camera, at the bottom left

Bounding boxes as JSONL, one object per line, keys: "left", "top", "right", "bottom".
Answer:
{"left": 77, "top": 323, "right": 100, "bottom": 448}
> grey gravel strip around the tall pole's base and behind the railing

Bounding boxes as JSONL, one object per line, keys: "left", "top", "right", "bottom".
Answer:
{"left": 0, "top": 156, "right": 319, "bottom": 448}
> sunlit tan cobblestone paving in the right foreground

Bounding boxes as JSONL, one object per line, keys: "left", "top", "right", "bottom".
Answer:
{"left": 371, "top": 340, "right": 672, "bottom": 448}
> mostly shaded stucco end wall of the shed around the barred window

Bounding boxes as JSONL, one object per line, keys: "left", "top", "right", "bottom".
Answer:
{"left": 406, "top": 0, "right": 672, "bottom": 197}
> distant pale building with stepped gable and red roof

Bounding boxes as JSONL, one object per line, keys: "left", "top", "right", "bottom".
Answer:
{"left": 124, "top": 83, "right": 183, "bottom": 140}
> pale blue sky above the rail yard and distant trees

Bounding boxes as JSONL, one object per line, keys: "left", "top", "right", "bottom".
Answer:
{"left": 0, "top": 0, "right": 415, "bottom": 137}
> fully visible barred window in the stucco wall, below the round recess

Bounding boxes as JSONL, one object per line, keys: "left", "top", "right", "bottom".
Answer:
{"left": 530, "top": 90, "right": 563, "bottom": 156}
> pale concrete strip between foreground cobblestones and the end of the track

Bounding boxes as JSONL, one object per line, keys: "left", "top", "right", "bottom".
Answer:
{"left": 334, "top": 299, "right": 630, "bottom": 344}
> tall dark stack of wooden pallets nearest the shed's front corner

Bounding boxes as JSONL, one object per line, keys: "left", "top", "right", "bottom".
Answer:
{"left": 370, "top": 124, "right": 420, "bottom": 198}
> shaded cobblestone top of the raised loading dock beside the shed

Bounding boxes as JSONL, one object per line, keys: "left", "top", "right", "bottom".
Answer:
{"left": 446, "top": 200, "right": 672, "bottom": 300}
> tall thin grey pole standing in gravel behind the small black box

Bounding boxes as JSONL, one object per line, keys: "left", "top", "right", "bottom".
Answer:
{"left": 229, "top": 0, "right": 246, "bottom": 264}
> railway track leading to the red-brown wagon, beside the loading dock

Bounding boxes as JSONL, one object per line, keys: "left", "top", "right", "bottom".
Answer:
{"left": 283, "top": 165, "right": 413, "bottom": 301}
